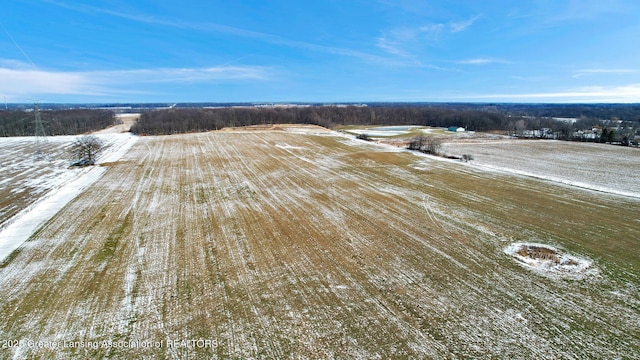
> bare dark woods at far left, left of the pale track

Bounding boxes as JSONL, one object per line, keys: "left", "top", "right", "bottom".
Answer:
{"left": 0, "top": 109, "right": 116, "bottom": 136}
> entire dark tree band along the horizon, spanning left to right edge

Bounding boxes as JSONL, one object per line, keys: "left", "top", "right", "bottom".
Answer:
{"left": 0, "top": 103, "right": 640, "bottom": 137}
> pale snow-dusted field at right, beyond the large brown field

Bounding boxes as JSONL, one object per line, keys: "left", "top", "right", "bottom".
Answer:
{"left": 442, "top": 140, "right": 640, "bottom": 198}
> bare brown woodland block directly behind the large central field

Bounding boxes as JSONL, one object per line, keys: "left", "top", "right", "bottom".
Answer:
{"left": 131, "top": 106, "right": 506, "bottom": 135}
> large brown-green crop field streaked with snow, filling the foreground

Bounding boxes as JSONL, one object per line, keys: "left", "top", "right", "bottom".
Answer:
{"left": 0, "top": 130, "right": 640, "bottom": 359}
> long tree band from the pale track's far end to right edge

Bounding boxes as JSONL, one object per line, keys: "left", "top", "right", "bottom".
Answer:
{"left": 131, "top": 104, "right": 640, "bottom": 145}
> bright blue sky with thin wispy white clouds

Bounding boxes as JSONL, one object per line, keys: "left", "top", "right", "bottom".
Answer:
{"left": 0, "top": 0, "right": 640, "bottom": 103}
